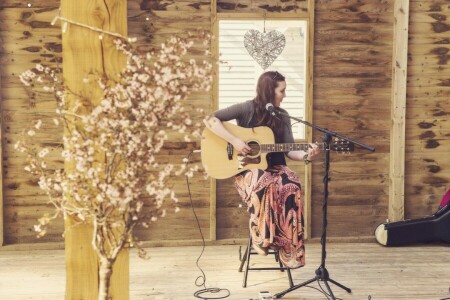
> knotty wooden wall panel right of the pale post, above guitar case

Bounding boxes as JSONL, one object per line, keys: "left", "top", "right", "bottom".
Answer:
{"left": 405, "top": 0, "right": 450, "bottom": 219}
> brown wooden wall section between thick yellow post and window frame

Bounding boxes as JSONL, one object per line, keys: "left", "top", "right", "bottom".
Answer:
{"left": 128, "top": 0, "right": 211, "bottom": 241}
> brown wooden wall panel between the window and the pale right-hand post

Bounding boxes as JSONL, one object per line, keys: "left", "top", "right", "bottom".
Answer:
{"left": 312, "top": 0, "right": 393, "bottom": 237}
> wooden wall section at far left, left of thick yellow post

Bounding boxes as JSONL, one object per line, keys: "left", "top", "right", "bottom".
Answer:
{"left": 0, "top": 1, "right": 64, "bottom": 244}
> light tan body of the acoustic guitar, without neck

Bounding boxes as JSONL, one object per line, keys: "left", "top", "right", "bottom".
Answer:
{"left": 201, "top": 122, "right": 275, "bottom": 179}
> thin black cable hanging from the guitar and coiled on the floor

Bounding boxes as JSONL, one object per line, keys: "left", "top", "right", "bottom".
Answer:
{"left": 186, "top": 150, "right": 230, "bottom": 299}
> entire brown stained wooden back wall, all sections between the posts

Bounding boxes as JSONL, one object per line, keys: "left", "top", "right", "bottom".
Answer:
{"left": 0, "top": 0, "right": 450, "bottom": 244}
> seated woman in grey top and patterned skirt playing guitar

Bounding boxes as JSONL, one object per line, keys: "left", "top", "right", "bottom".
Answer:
{"left": 205, "top": 71, "right": 320, "bottom": 268}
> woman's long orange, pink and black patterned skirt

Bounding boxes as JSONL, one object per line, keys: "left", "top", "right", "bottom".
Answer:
{"left": 235, "top": 166, "right": 305, "bottom": 269}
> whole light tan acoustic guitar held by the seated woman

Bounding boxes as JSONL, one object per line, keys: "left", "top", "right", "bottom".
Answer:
{"left": 201, "top": 122, "right": 354, "bottom": 179}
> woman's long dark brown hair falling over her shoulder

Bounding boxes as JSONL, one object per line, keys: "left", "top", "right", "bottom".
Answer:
{"left": 254, "top": 71, "right": 286, "bottom": 136}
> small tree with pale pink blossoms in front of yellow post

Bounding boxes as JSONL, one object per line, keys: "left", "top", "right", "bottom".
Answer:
{"left": 15, "top": 32, "right": 211, "bottom": 299}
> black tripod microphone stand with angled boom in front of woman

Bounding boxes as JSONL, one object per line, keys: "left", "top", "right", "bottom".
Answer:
{"left": 266, "top": 106, "right": 375, "bottom": 300}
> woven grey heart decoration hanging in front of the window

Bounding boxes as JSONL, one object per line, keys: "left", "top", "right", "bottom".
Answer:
{"left": 244, "top": 29, "right": 286, "bottom": 70}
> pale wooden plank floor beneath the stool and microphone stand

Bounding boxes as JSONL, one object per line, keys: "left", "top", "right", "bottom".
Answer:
{"left": 0, "top": 243, "right": 450, "bottom": 300}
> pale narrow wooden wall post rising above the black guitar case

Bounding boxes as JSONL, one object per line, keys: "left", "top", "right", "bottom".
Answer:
{"left": 388, "top": 0, "right": 409, "bottom": 222}
